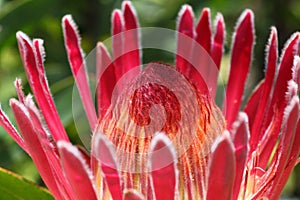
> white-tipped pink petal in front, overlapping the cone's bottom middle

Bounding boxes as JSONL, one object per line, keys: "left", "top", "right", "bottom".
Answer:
{"left": 149, "top": 134, "right": 178, "bottom": 200}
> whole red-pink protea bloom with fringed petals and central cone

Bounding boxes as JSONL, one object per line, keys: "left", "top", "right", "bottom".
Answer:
{"left": 0, "top": 1, "right": 300, "bottom": 200}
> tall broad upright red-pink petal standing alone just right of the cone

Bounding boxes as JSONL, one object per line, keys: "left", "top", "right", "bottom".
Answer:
{"left": 224, "top": 10, "right": 254, "bottom": 129}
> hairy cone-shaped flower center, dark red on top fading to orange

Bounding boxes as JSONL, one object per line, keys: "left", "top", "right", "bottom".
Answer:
{"left": 95, "top": 63, "right": 224, "bottom": 197}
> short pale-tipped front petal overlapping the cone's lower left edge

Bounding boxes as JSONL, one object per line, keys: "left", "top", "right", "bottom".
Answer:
{"left": 92, "top": 133, "right": 123, "bottom": 200}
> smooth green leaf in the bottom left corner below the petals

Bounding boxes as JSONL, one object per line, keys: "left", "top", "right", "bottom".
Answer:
{"left": 0, "top": 168, "right": 54, "bottom": 200}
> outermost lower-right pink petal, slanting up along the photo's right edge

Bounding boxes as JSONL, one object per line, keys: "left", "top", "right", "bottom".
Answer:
{"left": 253, "top": 96, "right": 300, "bottom": 199}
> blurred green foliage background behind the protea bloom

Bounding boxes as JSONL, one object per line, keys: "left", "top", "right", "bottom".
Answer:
{"left": 0, "top": 0, "right": 300, "bottom": 197}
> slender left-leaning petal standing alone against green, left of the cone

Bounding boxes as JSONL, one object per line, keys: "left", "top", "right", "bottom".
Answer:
{"left": 62, "top": 15, "right": 97, "bottom": 131}
